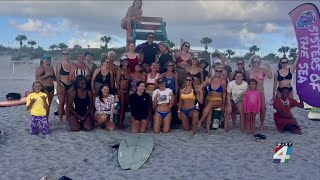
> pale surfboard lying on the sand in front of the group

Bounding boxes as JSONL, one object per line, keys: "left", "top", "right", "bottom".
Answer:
{"left": 118, "top": 134, "right": 153, "bottom": 170}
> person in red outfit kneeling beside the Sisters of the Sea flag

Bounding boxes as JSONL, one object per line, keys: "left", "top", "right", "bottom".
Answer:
{"left": 273, "top": 87, "right": 303, "bottom": 135}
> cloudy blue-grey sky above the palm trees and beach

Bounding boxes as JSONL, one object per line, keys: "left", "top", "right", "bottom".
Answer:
{"left": 0, "top": 0, "right": 319, "bottom": 55}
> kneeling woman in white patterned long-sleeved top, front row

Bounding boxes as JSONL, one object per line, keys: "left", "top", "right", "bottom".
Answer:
{"left": 94, "top": 85, "right": 115, "bottom": 131}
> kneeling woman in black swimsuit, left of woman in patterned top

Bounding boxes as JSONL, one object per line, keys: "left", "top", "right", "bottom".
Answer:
{"left": 66, "top": 76, "right": 93, "bottom": 131}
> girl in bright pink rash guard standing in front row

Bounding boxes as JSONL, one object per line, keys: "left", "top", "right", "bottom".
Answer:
{"left": 243, "top": 79, "right": 261, "bottom": 134}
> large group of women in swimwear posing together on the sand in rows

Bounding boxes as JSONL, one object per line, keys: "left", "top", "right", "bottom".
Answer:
{"left": 36, "top": 39, "right": 302, "bottom": 134}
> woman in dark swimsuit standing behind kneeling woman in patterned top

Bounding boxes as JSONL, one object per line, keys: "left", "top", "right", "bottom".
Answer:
{"left": 91, "top": 53, "right": 114, "bottom": 97}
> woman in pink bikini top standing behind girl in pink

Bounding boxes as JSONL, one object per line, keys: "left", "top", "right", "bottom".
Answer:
{"left": 247, "top": 55, "right": 272, "bottom": 130}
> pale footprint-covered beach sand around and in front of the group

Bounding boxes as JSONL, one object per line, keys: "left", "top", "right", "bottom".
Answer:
{"left": 0, "top": 56, "right": 320, "bottom": 180}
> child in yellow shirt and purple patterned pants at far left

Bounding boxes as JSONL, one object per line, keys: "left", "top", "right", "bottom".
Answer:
{"left": 26, "top": 81, "right": 49, "bottom": 135}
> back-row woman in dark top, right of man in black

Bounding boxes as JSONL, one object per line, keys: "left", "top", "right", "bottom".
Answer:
{"left": 156, "top": 42, "right": 174, "bottom": 73}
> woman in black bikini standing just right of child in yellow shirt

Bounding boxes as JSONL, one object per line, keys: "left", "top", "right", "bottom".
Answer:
{"left": 56, "top": 50, "right": 73, "bottom": 123}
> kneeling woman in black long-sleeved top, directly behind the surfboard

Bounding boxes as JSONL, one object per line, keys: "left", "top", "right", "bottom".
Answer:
{"left": 130, "top": 81, "right": 150, "bottom": 133}
